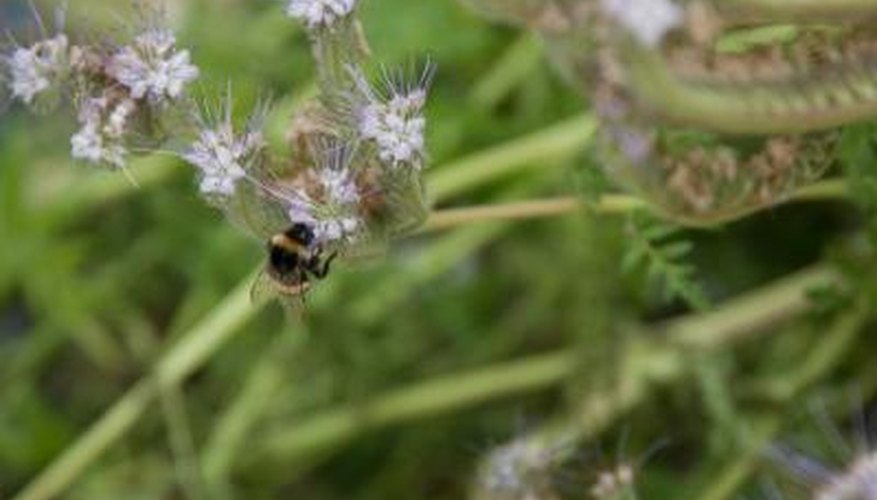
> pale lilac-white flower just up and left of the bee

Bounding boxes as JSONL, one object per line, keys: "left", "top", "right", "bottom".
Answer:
{"left": 183, "top": 122, "right": 264, "bottom": 196}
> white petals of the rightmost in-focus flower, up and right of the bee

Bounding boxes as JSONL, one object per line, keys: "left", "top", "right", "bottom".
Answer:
{"left": 359, "top": 88, "right": 426, "bottom": 168}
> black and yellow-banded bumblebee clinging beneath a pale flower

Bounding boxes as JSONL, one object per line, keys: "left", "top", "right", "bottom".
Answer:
{"left": 266, "top": 222, "right": 338, "bottom": 296}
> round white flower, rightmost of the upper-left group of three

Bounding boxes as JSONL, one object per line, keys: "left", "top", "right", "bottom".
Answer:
{"left": 108, "top": 29, "right": 199, "bottom": 102}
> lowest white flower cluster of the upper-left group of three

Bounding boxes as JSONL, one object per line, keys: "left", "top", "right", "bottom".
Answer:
{"left": 70, "top": 97, "right": 137, "bottom": 168}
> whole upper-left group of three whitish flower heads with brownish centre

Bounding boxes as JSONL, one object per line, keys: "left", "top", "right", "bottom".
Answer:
{"left": 0, "top": 9, "right": 199, "bottom": 168}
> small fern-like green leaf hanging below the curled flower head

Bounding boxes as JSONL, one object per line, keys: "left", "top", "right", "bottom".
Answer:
{"left": 621, "top": 211, "right": 710, "bottom": 310}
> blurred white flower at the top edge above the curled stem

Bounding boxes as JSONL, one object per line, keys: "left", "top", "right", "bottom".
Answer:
{"left": 602, "top": 0, "right": 683, "bottom": 47}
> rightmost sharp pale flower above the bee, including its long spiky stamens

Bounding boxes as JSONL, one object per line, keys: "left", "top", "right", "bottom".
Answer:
{"left": 353, "top": 64, "right": 434, "bottom": 169}
